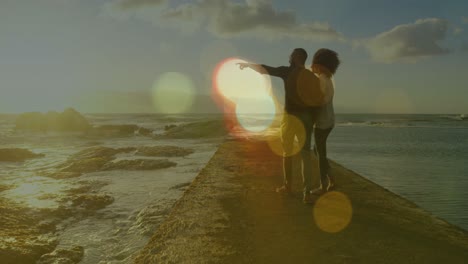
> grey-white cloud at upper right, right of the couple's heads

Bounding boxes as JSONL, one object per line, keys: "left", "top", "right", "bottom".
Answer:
{"left": 359, "top": 18, "right": 450, "bottom": 63}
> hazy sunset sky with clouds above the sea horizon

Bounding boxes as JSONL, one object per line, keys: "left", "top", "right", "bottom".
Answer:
{"left": 0, "top": 0, "right": 468, "bottom": 114}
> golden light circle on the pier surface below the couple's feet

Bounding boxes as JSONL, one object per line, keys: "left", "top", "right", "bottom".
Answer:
{"left": 314, "top": 191, "right": 353, "bottom": 233}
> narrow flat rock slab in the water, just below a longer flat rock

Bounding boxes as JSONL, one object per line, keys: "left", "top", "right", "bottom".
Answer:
{"left": 102, "top": 159, "right": 177, "bottom": 170}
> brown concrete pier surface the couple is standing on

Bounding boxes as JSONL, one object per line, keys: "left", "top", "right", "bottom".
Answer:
{"left": 135, "top": 139, "right": 468, "bottom": 264}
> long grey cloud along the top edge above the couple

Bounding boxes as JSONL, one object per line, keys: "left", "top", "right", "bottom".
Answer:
{"left": 105, "top": 0, "right": 344, "bottom": 40}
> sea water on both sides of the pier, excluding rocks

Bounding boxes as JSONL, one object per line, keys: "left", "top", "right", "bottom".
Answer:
{"left": 0, "top": 114, "right": 468, "bottom": 263}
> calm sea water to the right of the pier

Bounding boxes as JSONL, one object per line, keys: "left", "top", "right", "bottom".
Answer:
{"left": 328, "top": 114, "right": 468, "bottom": 230}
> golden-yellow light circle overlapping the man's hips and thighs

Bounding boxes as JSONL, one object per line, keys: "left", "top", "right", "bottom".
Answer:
{"left": 268, "top": 113, "right": 306, "bottom": 157}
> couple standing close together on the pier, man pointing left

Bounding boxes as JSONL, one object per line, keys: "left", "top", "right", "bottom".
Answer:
{"left": 239, "top": 48, "right": 340, "bottom": 203}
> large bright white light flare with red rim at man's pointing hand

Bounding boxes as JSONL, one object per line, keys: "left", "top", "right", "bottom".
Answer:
{"left": 213, "top": 58, "right": 271, "bottom": 102}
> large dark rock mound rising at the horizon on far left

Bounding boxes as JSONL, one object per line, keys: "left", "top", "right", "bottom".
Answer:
{"left": 15, "top": 108, "right": 91, "bottom": 132}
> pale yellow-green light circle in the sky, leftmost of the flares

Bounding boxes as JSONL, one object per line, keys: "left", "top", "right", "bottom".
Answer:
{"left": 152, "top": 72, "right": 195, "bottom": 114}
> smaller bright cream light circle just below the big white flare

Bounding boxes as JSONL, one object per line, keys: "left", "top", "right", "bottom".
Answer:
{"left": 236, "top": 94, "right": 276, "bottom": 132}
